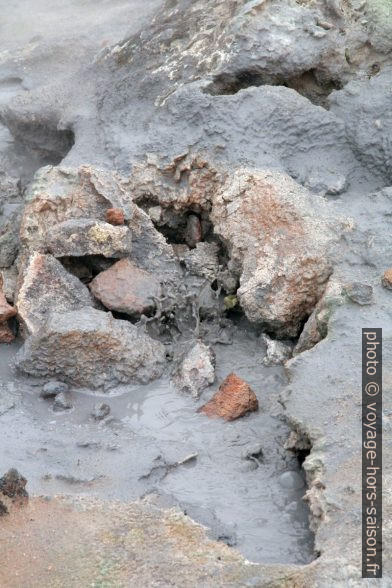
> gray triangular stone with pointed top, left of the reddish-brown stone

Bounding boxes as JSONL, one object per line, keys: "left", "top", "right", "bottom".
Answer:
{"left": 16, "top": 253, "right": 94, "bottom": 333}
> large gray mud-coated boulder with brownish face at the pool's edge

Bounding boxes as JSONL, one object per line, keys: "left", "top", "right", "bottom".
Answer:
{"left": 16, "top": 307, "right": 165, "bottom": 390}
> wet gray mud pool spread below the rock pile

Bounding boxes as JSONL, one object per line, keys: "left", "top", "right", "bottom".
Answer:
{"left": 0, "top": 326, "right": 313, "bottom": 563}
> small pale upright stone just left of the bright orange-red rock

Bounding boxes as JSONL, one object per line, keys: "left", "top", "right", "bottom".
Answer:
{"left": 172, "top": 341, "right": 215, "bottom": 398}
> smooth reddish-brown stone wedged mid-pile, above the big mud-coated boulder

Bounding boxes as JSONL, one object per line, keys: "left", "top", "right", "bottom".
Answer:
{"left": 90, "top": 259, "right": 160, "bottom": 316}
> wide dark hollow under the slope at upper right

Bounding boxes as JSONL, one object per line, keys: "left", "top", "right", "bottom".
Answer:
{"left": 204, "top": 67, "right": 343, "bottom": 108}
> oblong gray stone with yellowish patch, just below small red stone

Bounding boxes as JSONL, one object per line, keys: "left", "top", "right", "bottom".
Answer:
{"left": 46, "top": 219, "right": 132, "bottom": 258}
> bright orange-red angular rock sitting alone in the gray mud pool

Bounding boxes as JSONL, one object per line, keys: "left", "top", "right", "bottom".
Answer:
{"left": 200, "top": 374, "right": 259, "bottom": 421}
